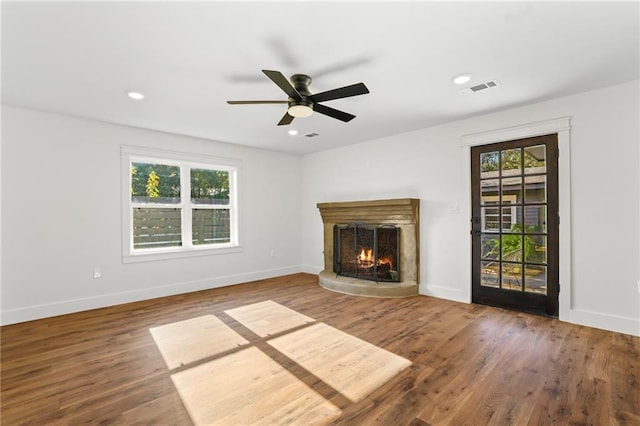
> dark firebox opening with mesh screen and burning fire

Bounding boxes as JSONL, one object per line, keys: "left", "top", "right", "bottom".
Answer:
{"left": 333, "top": 223, "right": 400, "bottom": 282}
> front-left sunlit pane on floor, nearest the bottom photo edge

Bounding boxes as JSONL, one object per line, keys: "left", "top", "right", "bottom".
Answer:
{"left": 171, "top": 347, "right": 341, "bottom": 425}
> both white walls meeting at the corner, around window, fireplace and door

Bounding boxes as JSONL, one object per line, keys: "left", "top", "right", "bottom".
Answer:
{"left": 1, "top": 81, "right": 640, "bottom": 335}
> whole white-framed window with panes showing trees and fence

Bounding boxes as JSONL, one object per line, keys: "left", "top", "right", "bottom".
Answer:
{"left": 122, "top": 147, "right": 239, "bottom": 261}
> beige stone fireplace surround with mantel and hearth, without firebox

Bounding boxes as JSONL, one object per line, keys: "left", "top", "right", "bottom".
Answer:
{"left": 317, "top": 198, "right": 420, "bottom": 297}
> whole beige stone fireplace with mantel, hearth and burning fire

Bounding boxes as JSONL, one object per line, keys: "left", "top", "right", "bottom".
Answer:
{"left": 318, "top": 198, "right": 420, "bottom": 297}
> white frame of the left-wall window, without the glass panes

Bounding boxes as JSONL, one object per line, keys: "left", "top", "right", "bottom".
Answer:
{"left": 121, "top": 145, "right": 242, "bottom": 263}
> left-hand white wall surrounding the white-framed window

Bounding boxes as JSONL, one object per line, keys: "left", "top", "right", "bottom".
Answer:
{"left": 2, "top": 107, "right": 302, "bottom": 324}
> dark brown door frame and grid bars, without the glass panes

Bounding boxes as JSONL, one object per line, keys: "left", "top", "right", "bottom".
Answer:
{"left": 471, "top": 133, "right": 559, "bottom": 317}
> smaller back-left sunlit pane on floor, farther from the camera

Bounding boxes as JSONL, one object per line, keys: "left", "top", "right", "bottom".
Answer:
{"left": 149, "top": 315, "right": 249, "bottom": 370}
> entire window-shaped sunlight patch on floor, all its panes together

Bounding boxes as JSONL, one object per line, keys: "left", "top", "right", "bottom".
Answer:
{"left": 149, "top": 300, "right": 411, "bottom": 425}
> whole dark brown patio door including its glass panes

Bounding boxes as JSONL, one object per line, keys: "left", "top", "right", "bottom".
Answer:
{"left": 471, "top": 134, "right": 559, "bottom": 316}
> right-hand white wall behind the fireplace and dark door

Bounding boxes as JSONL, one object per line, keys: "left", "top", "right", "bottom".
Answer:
{"left": 302, "top": 81, "right": 640, "bottom": 335}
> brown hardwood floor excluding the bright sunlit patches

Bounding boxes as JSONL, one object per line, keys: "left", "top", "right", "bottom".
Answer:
{"left": 0, "top": 274, "right": 640, "bottom": 426}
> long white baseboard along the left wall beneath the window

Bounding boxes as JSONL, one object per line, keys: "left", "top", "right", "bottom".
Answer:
{"left": 0, "top": 265, "right": 304, "bottom": 325}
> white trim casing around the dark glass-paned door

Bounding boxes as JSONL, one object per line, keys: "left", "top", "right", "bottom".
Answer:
{"left": 460, "top": 117, "right": 572, "bottom": 321}
